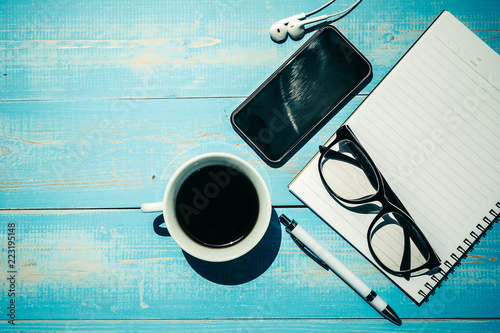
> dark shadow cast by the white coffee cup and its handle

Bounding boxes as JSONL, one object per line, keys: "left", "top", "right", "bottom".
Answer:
{"left": 153, "top": 209, "right": 281, "bottom": 285}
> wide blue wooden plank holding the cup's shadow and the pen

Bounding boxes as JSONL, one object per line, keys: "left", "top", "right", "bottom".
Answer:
{"left": 0, "top": 208, "right": 500, "bottom": 321}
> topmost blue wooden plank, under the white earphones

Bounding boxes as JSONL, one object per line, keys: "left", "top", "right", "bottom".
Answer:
{"left": 0, "top": 0, "right": 500, "bottom": 101}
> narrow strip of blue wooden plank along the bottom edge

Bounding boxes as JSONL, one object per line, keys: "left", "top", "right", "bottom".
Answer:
{"left": 0, "top": 319, "right": 500, "bottom": 333}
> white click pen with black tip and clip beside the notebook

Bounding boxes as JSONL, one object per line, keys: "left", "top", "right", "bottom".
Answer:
{"left": 280, "top": 215, "right": 402, "bottom": 326}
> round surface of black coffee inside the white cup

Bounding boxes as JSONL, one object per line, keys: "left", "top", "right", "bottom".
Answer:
{"left": 175, "top": 165, "right": 259, "bottom": 247}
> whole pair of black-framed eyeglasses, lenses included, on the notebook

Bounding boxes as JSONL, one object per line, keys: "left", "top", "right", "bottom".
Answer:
{"left": 318, "top": 125, "right": 440, "bottom": 280}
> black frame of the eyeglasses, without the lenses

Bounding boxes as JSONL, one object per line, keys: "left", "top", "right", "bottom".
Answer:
{"left": 318, "top": 125, "right": 441, "bottom": 280}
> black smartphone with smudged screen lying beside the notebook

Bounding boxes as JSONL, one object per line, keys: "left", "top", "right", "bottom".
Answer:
{"left": 231, "top": 25, "right": 372, "bottom": 165}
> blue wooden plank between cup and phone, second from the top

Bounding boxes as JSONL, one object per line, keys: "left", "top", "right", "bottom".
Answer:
{"left": 0, "top": 98, "right": 362, "bottom": 208}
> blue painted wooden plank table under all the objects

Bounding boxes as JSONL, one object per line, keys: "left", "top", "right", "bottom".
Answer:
{"left": 0, "top": 0, "right": 500, "bottom": 332}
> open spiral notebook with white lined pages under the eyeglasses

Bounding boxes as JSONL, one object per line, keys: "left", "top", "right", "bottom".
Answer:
{"left": 289, "top": 11, "right": 500, "bottom": 305}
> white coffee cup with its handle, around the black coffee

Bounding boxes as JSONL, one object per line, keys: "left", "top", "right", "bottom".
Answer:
{"left": 141, "top": 153, "right": 272, "bottom": 262}
